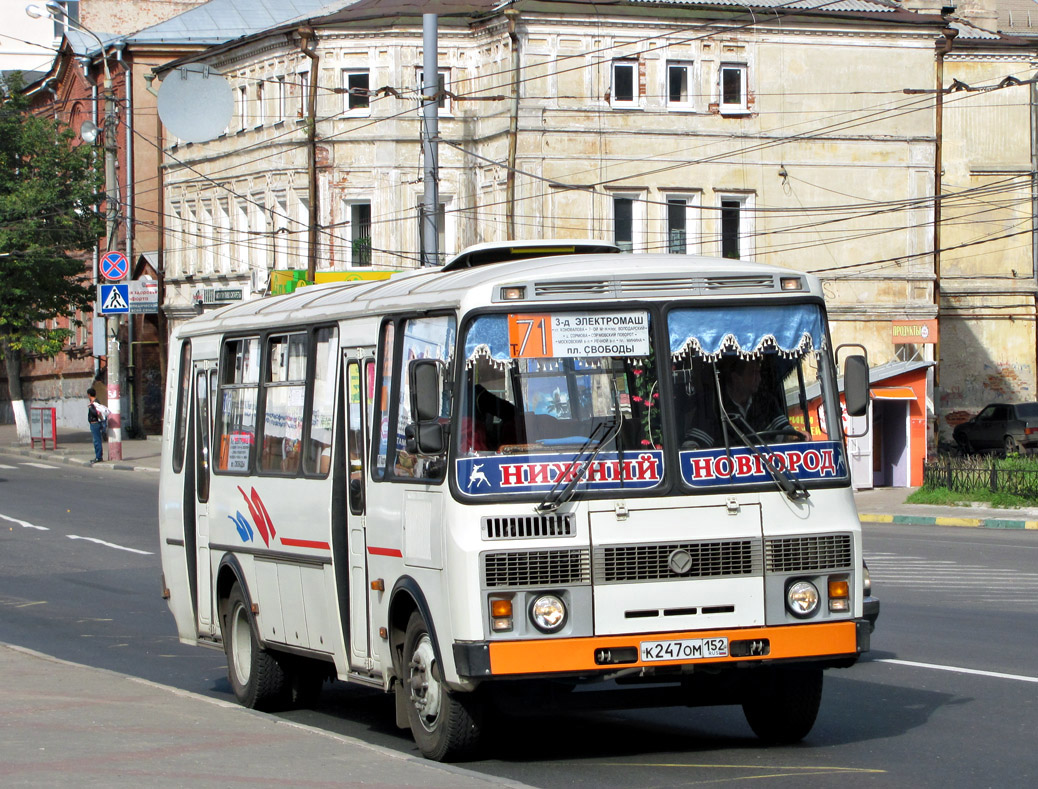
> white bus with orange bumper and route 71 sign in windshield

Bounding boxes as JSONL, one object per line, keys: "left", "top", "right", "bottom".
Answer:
{"left": 160, "top": 242, "right": 878, "bottom": 760}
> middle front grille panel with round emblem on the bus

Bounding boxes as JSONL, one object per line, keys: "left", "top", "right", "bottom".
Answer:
{"left": 595, "top": 540, "right": 761, "bottom": 583}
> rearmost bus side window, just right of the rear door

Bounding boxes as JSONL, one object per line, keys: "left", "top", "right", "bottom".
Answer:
{"left": 215, "top": 337, "right": 260, "bottom": 473}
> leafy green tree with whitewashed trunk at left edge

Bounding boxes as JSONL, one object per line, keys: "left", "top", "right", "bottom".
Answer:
{"left": 0, "top": 73, "right": 104, "bottom": 442}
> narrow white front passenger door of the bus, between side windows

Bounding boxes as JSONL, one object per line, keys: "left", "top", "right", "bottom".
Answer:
{"left": 343, "top": 348, "right": 375, "bottom": 671}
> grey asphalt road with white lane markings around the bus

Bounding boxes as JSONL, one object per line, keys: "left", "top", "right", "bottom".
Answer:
{"left": 0, "top": 454, "right": 1038, "bottom": 787}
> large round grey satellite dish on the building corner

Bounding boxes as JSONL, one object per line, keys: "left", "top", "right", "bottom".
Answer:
{"left": 159, "top": 63, "right": 235, "bottom": 142}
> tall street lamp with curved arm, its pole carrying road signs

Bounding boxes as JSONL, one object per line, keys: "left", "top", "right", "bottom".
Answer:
{"left": 25, "top": 0, "right": 122, "bottom": 460}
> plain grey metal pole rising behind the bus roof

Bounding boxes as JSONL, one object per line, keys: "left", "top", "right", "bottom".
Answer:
{"left": 421, "top": 13, "right": 440, "bottom": 266}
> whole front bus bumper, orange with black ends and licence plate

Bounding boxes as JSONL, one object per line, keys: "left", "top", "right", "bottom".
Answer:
{"left": 454, "top": 618, "right": 872, "bottom": 678}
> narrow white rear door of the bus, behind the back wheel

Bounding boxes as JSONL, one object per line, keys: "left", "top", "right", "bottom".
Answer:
{"left": 192, "top": 361, "right": 217, "bottom": 635}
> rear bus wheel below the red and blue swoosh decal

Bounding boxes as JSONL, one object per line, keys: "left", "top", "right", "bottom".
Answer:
{"left": 221, "top": 583, "right": 288, "bottom": 710}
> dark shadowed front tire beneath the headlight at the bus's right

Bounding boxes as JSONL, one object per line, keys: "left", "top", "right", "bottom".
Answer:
{"left": 742, "top": 668, "right": 822, "bottom": 745}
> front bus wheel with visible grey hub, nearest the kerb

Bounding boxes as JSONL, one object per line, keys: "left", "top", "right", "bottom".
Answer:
{"left": 401, "top": 611, "right": 483, "bottom": 762}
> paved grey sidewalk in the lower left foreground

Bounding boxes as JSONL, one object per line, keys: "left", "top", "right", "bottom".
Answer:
{"left": 0, "top": 643, "right": 523, "bottom": 789}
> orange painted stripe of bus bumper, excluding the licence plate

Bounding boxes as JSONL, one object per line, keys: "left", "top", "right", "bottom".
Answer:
{"left": 490, "top": 621, "right": 857, "bottom": 676}
